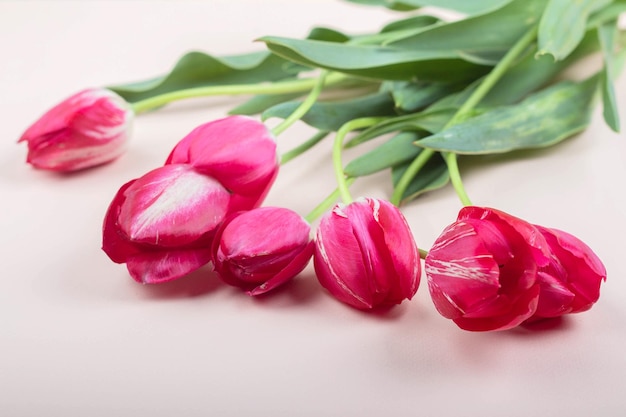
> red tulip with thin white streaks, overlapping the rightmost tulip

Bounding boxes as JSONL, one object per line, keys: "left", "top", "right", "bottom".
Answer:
{"left": 425, "top": 207, "right": 550, "bottom": 331}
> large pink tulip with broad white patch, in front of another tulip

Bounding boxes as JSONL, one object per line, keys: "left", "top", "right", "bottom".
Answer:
{"left": 102, "top": 164, "right": 230, "bottom": 283}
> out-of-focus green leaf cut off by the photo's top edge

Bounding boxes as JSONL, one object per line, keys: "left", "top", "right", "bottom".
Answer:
{"left": 348, "top": 0, "right": 511, "bottom": 14}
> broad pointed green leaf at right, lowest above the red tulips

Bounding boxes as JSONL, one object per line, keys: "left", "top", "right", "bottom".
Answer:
{"left": 416, "top": 76, "right": 598, "bottom": 154}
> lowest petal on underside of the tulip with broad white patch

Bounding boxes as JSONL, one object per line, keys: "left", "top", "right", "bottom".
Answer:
{"left": 126, "top": 248, "right": 211, "bottom": 284}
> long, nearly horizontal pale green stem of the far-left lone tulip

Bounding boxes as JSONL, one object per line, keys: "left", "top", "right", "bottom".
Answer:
{"left": 131, "top": 73, "right": 348, "bottom": 114}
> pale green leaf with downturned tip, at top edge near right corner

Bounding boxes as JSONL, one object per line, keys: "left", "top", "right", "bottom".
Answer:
{"left": 538, "top": 0, "right": 612, "bottom": 61}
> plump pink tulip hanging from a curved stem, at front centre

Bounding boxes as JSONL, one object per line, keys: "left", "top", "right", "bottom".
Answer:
{"left": 313, "top": 198, "right": 420, "bottom": 310}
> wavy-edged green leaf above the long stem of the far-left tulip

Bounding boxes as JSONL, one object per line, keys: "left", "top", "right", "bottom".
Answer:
{"left": 109, "top": 51, "right": 305, "bottom": 103}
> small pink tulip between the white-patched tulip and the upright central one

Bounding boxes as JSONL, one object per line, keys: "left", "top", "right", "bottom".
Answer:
{"left": 213, "top": 207, "right": 314, "bottom": 295}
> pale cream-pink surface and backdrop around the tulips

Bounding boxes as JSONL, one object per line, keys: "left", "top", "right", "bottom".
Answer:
{"left": 0, "top": 0, "right": 626, "bottom": 417}
